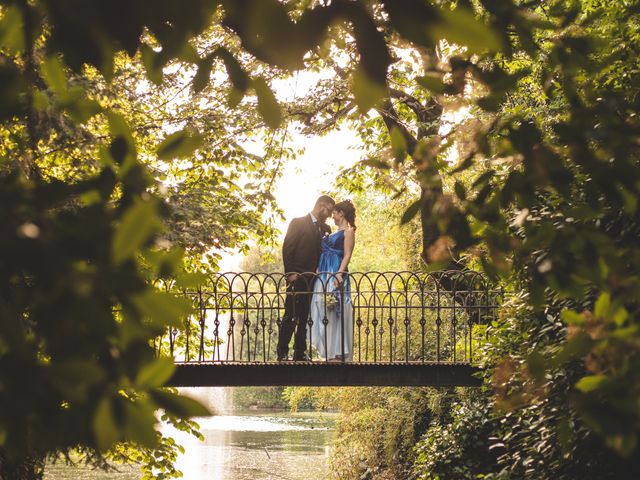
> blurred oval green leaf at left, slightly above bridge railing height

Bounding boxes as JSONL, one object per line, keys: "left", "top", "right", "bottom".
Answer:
{"left": 111, "top": 201, "right": 160, "bottom": 264}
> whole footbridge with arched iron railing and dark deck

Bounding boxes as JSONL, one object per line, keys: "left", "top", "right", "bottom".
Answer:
{"left": 156, "top": 271, "right": 504, "bottom": 386}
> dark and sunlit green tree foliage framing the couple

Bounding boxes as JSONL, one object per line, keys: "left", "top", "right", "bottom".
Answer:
{"left": 0, "top": 0, "right": 640, "bottom": 477}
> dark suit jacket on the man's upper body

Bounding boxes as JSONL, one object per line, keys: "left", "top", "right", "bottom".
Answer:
{"left": 282, "top": 214, "right": 331, "bottom": 273}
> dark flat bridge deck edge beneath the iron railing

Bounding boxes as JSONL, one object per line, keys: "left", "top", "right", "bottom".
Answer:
{"left": 169, "top": 361, "right": 481, "bottom": 387}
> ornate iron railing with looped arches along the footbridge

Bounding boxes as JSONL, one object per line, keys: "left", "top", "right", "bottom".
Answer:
{"left": 156, "top": 271, "right": 504, "bottom": 364}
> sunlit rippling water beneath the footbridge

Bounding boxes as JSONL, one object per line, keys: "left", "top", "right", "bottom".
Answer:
{"left": 45, "top": 389, "right": 334, "bottom": 480}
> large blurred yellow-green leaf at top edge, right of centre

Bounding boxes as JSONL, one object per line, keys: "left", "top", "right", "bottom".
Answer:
{"left": 432, "top": 8, "right": 502, "bottom": 53}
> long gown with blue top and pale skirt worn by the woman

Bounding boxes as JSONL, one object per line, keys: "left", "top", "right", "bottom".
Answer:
{"left": 309, "top": 230, "right": 353, "bottom": 361}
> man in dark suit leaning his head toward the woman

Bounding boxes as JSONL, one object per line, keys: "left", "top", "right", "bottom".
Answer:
{"left": 278, "top": 195, "right": 336, "bottom": 360}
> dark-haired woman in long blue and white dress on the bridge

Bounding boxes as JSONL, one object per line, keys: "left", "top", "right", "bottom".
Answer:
{"left": 309, "top": 200, "right": 356, "bottom": 361}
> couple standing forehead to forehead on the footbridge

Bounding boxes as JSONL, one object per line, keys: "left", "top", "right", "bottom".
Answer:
{"left": 278, "top": 195, "right": 356, "bottom": 361}
